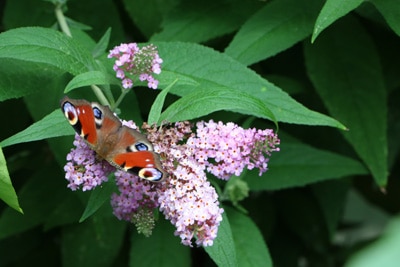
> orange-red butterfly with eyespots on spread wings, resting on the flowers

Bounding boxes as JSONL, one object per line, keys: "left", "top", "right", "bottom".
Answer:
{"left": 60, "top": 96, "right": 167, "bottom": 182}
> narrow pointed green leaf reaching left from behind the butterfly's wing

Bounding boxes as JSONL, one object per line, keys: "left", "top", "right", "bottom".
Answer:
{"left": 0, "top": 110, "right": 74, "bottom": 147}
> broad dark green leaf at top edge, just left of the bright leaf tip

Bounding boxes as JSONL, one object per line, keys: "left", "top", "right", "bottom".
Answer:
{"left": 225, "top": 0, "right": 321, "bottom": 65}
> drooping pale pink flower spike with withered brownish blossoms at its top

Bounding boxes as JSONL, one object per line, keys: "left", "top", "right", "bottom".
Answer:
{"left": 144, "top": 122, "right": 223, "bottom": 246}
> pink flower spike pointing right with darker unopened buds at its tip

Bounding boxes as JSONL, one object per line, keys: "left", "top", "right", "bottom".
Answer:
{"left": 187, "top": 120, "right": 279, "bottom": 180}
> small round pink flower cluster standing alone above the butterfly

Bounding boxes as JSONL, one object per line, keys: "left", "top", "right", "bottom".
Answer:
{"left": 108, "top": 43, "right": 162, "bottom": 89}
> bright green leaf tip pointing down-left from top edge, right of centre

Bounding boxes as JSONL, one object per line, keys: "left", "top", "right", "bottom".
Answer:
{"left": 311, "top": 0, "right": 364, "bottom": 43}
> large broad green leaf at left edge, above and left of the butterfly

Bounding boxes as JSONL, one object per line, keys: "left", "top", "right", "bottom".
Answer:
{"left": 0, "top": 27, "right": 98, "bottom": 100}
